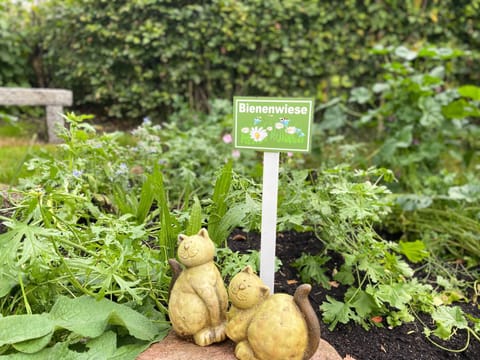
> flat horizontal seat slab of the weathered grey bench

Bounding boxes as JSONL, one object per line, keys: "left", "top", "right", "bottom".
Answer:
{"left": 0, "top": 87, "right": 73, "bottom": 106}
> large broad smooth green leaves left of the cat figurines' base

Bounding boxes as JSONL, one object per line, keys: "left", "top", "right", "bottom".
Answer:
{"left": 0, "top": 296, "right": 170, "bottom": 359}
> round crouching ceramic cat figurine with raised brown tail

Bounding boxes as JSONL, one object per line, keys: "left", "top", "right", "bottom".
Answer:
{"left": 226, "top": 267, "right": 320, "bottom": 360}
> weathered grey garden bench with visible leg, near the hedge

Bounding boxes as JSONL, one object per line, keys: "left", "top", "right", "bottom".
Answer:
{"left": 0, "top": 87, "right": 73, "bottom": 142}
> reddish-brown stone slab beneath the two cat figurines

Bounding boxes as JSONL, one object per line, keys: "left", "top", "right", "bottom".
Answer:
{"left": 137, "top": 331, "right": 342, "bottom": 360}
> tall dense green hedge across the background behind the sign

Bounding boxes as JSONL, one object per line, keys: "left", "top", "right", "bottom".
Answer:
{"left": 27, "top": 0, "right": 480, "bottom": 121}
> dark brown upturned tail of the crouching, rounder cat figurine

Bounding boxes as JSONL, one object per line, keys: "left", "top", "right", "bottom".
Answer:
{"left": 293, "top": 284, "right": 320, "bottom": 360}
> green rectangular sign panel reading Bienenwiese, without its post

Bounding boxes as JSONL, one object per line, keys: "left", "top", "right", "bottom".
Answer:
{"left": 233, "top": 97, "right": 313, "bottom": 152}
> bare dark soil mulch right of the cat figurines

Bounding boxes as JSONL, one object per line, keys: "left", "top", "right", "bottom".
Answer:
{"left": 228, "top": 230, "right": 480, "bottom": 360}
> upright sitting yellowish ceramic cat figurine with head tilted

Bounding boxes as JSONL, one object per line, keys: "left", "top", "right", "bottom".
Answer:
{"left": 168, "top": 229, "right": 228, "bottom": 346}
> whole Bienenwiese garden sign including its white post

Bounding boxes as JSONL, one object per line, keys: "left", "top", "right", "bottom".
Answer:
{"left": 233, "top": 97, "right": 313, "bottom": 293}
